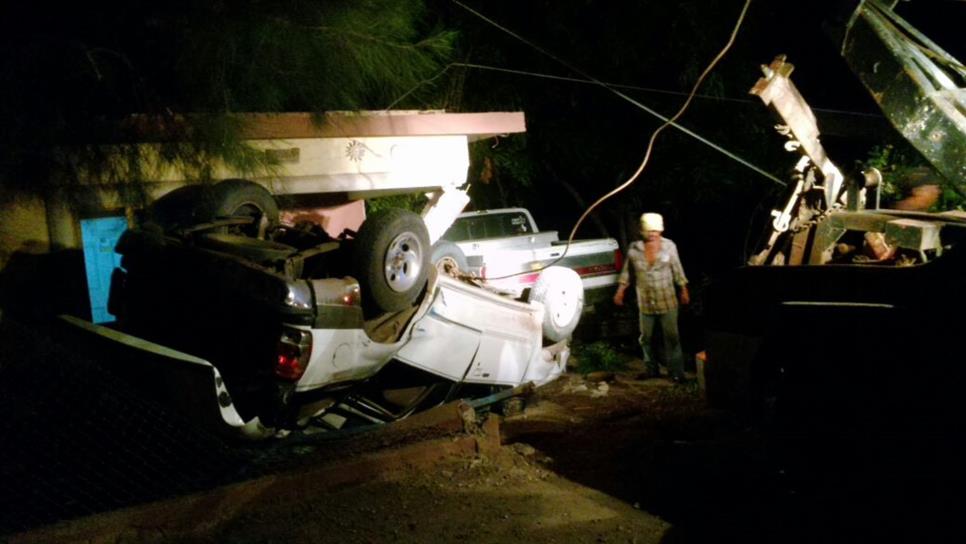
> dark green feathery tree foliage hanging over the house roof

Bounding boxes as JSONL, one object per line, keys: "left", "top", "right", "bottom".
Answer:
{"left": 0, "top": 0, "right": 454, "bottom": 197}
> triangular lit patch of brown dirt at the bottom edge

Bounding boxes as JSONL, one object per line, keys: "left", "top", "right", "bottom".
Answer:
{"left": 192, "top": 447, "right": 669, "bottom": 543}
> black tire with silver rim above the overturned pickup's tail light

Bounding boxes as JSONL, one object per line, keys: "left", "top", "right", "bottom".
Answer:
{"left": 352, "top": 208, "right": 430, "bottom": 312}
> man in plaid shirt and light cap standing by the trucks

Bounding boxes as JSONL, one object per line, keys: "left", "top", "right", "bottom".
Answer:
{"left": 614, "top": 213, "right": 691, "bottom": 383}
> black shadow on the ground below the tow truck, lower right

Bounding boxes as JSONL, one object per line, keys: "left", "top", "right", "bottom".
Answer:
{"left": 506, "top": 377, "right": 966, "bottom": 542}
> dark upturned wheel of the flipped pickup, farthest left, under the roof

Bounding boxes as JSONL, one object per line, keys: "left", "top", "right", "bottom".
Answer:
{"left": 209, "top": 179, "right": 278, "bottom": 238}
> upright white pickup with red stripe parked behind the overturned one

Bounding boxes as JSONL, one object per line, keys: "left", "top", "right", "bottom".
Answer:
{"left": 432, "top": 208, "right": 623, "bottom": 311}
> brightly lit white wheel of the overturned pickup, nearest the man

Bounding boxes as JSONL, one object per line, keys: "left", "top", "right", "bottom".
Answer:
{"left": 527, "top": 266, "right": 584, "bottom": 342}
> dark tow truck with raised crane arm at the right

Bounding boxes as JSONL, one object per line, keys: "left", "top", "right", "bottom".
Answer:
{"left": 704, "top": 0, "right": 966, "bottom": 432}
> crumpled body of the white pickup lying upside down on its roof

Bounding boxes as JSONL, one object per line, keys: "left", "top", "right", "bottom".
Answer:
{"left": 111, "top": 212, "right": 580, "bottom": 436}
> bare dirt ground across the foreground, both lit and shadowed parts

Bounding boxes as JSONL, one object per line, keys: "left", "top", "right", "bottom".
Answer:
{"left": 15, "top": 350, "right": 966, "bottom": 544}
